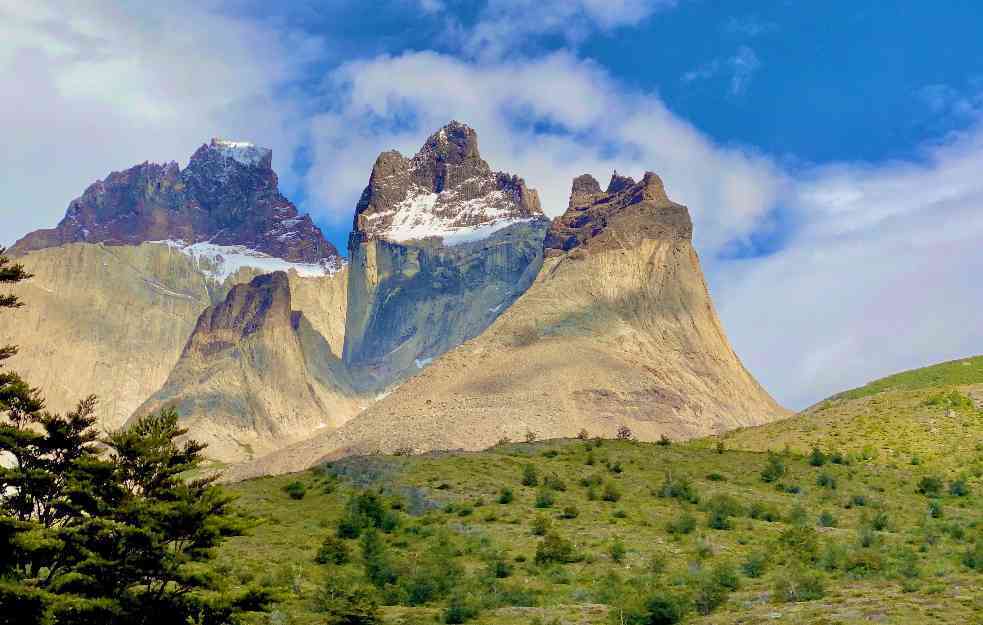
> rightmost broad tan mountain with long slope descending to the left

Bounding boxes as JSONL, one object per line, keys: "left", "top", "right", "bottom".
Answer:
{"left": 232, "top": 168, "right": 786, "bottom": 477}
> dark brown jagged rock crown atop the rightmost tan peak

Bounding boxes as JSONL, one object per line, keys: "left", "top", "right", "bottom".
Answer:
{"left": 543, "top": 171, "right": 693, "bottom": 256}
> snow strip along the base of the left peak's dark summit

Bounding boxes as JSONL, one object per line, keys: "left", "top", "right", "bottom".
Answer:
{"left": 150, "top": 240, "right": 344, "bottom": 282}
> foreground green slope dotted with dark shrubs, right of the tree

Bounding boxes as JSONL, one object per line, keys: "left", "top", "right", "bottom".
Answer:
{"left": 216, "top": 440, "right": 983, "bottom": 625}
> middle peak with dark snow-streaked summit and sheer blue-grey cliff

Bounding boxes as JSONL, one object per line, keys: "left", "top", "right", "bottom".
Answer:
{"left": 344, "top": 122, "right": 548, "bottom": 390}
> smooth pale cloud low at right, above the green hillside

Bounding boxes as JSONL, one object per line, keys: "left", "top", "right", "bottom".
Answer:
{"left": 714, "top": 119, "right": 983, "bottom": 407}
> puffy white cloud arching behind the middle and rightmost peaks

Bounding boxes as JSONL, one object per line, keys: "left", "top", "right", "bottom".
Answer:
{"left": 308, "top": 47, "right": 784, "bottom": 254}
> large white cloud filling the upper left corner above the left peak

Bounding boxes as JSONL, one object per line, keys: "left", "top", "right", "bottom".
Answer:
{"left": 0, "top": 0, "right": 321, "bottom": 244}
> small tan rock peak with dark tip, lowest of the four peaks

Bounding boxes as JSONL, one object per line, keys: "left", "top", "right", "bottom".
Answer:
{"left": 131, "top": 272, "right": 362, "bottom": 462}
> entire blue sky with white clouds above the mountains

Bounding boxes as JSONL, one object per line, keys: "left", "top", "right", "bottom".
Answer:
{"left": 0, "top": 0, "right": 983, "bottom": 407}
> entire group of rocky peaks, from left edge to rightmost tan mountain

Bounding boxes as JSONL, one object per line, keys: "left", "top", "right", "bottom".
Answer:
{"left": 0, "top": 122, "right": 787, "bottom": 466}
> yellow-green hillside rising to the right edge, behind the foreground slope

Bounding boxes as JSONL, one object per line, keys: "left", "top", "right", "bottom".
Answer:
{"left": 722, "top": 356, "right": 983, "bottom": 474}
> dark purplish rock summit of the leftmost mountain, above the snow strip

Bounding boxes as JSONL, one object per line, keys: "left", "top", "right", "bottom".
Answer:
{"left": 11, "top": 139, "right": 340, "bottom": 268}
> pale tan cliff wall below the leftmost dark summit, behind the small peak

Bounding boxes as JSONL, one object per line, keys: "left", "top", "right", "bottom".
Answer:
{"left": 0, "top": 243, "right": 347, "bottom": 428}
